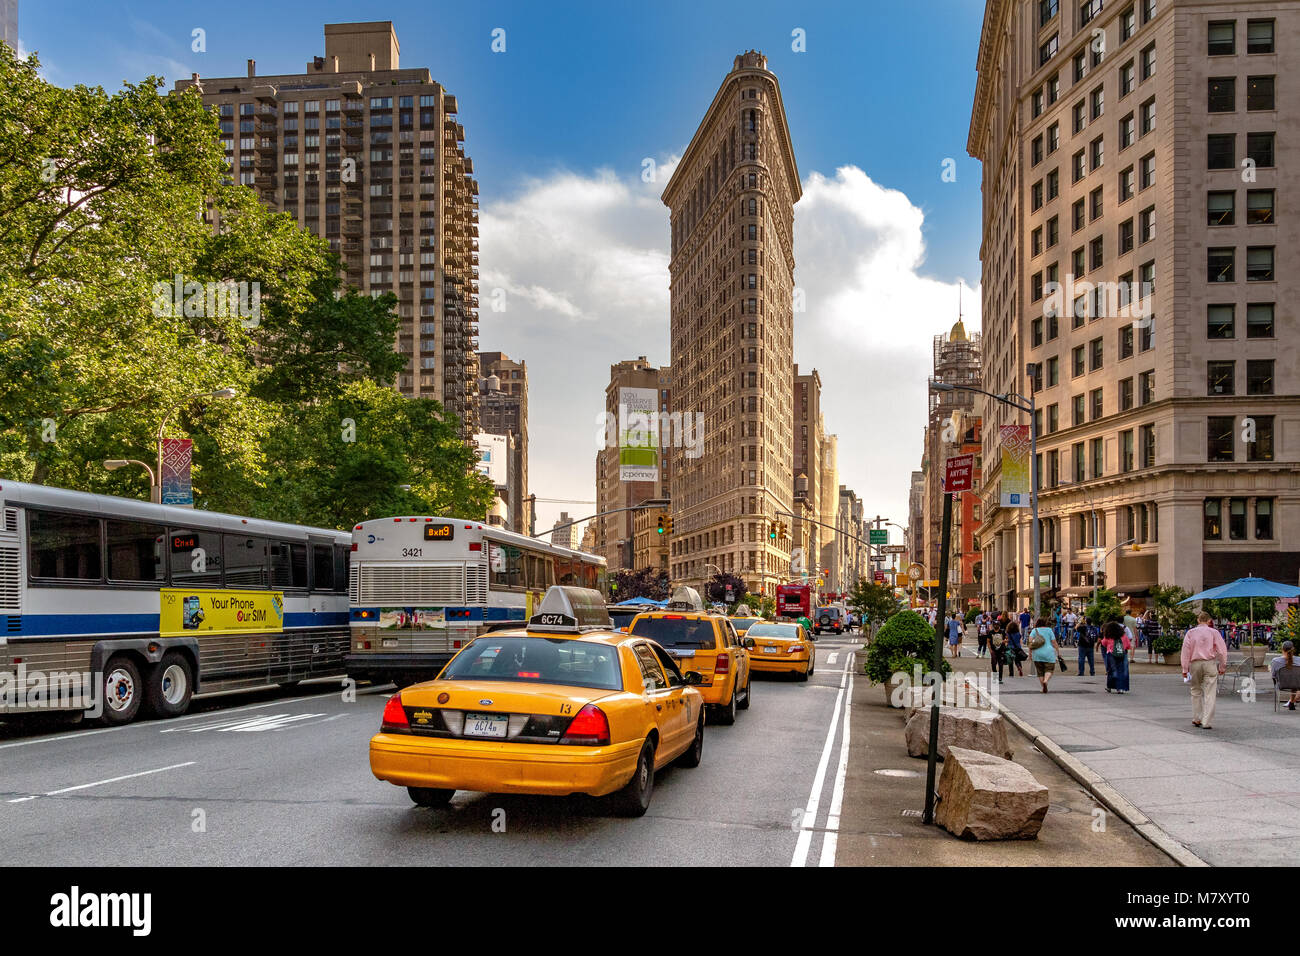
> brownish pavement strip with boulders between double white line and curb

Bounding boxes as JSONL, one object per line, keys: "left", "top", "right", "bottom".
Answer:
{"left": 836, "top": 650, "right": 1174, "bottom": 866}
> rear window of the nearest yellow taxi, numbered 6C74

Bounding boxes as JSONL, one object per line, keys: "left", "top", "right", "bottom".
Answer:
{"left": 439, "top": 635, "right": 623, "bottom": 691}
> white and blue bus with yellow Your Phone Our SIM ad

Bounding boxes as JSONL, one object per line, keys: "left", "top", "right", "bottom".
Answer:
{"left": 0, "top": 480, "right": 351, "bottom": 723}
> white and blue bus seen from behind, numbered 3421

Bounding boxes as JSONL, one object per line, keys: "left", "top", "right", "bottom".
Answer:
{"left": 345, "top": 515, "right": 607, "bottom": 687}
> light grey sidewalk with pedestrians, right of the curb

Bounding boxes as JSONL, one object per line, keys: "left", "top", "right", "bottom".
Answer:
{"left": 956, "top": 646, "right": 1300, "bottom": 866}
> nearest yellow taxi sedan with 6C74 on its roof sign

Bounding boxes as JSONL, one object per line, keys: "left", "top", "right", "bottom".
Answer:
{"left": 371, "top": 587, "right": 705, "bottom": 817}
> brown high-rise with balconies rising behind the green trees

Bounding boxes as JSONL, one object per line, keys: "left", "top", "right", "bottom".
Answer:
{"left": 176, "top": 21, "right": 478, "bottom": 438}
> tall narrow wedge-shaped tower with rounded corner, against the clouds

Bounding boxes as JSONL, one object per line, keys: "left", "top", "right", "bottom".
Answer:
{"left": 663, "top": 51, "right": 801, "bottom": 594}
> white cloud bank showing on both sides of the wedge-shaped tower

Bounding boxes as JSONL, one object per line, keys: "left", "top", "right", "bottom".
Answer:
{"left": 480, "top": 155, "right": 979, "bottom": 541}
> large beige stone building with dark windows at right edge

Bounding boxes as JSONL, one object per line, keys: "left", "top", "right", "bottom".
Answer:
{"left": 967, "top": 0, "right": 1300, "bottom": 606}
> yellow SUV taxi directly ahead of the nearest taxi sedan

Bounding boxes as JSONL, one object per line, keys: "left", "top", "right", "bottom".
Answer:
{"left": 628, "top": 588, "right": 754, "bottom": 724}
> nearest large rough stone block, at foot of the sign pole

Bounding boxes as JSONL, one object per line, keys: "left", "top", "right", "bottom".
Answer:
{"left": 935, "top": 747, "right": 1048, "bottom": 840}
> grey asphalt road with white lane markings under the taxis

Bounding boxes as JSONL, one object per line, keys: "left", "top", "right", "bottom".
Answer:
{"left": 0, "top": 636, "right": 857, "bottom": 866}
